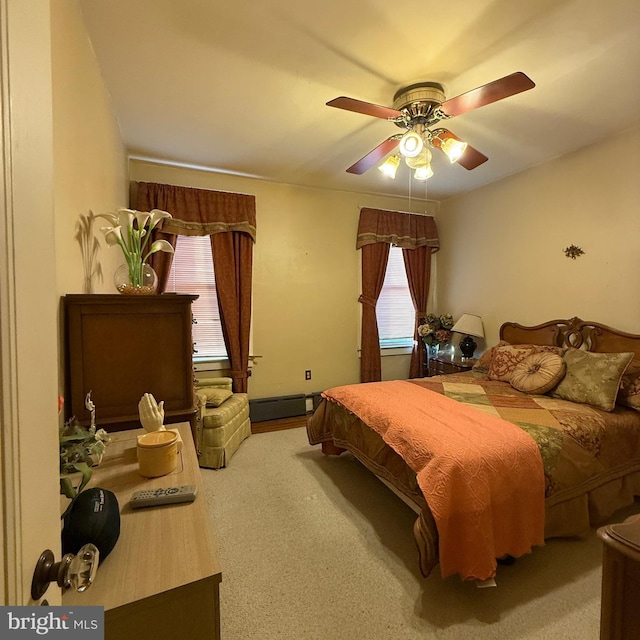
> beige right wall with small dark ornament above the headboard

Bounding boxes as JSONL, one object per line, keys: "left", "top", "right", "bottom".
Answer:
{"left": 437, "top": 127, "right": 640, "bottom": 356}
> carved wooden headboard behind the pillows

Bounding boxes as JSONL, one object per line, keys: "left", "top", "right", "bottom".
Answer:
{"left": 500, "top": 318, "right": 640, "bottom": 360}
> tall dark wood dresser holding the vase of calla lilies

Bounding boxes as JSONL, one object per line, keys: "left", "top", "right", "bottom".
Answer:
{"left": 63, "top": 293, "right": 197, "bottom": 431}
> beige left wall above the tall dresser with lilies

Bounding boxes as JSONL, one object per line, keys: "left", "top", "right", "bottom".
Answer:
{"left": 51, "top": 0, "right": 128, "bottom": 295}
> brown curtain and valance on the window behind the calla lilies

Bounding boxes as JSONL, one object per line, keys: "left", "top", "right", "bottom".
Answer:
{"left": 132, "top": 182, "right": 256, "bottom": 393}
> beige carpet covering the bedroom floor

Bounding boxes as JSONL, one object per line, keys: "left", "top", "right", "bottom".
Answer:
{"left": 202, "top": 429, "right": 628, "bottom": 640}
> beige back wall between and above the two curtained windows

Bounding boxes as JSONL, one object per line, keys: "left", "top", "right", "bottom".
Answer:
{"left": 130, "top": 161, "right": 436, "bottom": 398}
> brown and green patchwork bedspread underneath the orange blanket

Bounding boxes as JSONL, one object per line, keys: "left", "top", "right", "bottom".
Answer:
{"left": 307, "top": 373, "right": 640, "bottom": 578}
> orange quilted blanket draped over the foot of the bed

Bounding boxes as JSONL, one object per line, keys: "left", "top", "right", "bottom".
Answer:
{"left": 322, "top": 380, "right": 545, "bottom": 580}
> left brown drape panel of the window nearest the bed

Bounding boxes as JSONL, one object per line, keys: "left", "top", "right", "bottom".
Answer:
{"left": 358, "top": 242, "right": 390, "bottom": 382}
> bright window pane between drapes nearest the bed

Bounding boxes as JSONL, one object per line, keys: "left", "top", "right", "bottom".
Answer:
{"left": 376, "top": 246, "right": 416, "bottom": 348}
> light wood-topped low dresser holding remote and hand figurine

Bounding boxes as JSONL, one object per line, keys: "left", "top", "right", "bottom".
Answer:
{"left": 62, "top": 423, "right": 222, "bottom": 640}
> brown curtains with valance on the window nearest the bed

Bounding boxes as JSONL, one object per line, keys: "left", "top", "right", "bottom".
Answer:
{"left": 356, "top": 208, "right": 440, "bottom": 382}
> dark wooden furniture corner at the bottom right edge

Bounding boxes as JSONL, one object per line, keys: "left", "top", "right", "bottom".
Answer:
{"left": 598, "top": 515, "right": 640, "bottom": 640}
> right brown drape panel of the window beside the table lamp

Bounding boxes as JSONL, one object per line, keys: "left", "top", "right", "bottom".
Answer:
{"left": 402, "top": 246, "right": 431, "bottom": 378}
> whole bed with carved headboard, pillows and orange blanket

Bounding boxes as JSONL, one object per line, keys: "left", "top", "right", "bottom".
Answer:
{"left": 307, "top": 318, "right": 640, "bottom": 581}
